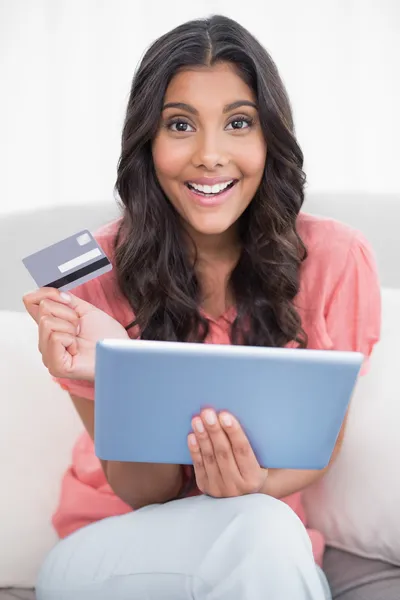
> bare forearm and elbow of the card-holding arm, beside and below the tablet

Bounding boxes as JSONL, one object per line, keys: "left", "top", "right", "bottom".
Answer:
{"left": 71, "top": 395, "right": 183, "bottom": 510}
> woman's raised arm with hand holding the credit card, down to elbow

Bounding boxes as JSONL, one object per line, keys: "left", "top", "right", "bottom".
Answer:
{"left": 24, "top": 288, "right": 188, "bottom": 509}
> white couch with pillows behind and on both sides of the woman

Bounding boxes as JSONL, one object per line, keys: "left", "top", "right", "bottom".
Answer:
{"left": 0, "top": 195, "right": 400, "bottom": 600}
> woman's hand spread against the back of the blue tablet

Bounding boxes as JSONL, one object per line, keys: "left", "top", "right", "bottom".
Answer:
{"left": 188, "top": 409, "right": 268, "bottom": 498}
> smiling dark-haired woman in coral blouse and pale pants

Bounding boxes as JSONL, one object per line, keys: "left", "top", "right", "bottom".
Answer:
{"left": 24, "top": 16, "right": 380, "bottom": 600}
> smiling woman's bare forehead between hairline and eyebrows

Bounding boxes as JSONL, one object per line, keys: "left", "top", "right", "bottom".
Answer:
{"left": 164, "top": 63, "right": 256, "bottom": 110}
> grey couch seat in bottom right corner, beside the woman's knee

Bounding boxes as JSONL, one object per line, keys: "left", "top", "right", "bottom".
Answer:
{"left": 324, "top": 548, "right": 400, "bottom": 600}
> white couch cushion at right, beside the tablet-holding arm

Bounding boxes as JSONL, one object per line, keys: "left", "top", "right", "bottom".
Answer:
{"left": 303, "top": 289, "right": 400, "bottom": 564}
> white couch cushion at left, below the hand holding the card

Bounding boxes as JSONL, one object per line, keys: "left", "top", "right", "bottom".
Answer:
{"left": 0, "top": 311, "right": 82, "bottom": 587}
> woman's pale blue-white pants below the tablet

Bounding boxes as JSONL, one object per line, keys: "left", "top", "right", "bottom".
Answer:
{"left": 36, "top": 494, "right": 331, "bottom": 600}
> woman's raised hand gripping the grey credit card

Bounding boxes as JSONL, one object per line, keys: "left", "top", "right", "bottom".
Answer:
{"left": 23, "top": 288, "right": 129, "bottom": 381}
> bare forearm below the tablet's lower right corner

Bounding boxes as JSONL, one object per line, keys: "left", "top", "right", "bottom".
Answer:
{"left": 260, "top": 414, "right": 348, "bottom": 498}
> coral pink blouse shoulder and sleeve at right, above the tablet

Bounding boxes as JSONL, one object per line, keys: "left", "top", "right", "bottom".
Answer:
{"left": 296, "top": 213, "right": 381, "bottom": 364}
